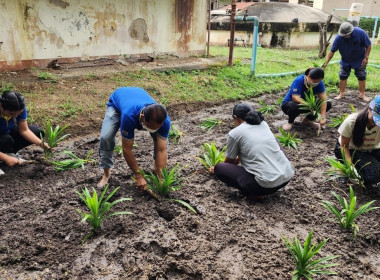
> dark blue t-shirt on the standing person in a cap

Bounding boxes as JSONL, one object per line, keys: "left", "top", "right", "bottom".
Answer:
{"left": 331, "top": 27, "right": 371, "bottom": 69}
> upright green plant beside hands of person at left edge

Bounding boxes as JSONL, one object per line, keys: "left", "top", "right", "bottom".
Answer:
{"left": 40, "top": 120, "right": 70, "bottom": 159}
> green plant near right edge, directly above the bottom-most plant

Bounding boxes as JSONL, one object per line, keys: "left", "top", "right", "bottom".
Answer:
{"left": 321, "top": 186, "right": 380, "bottom": 236}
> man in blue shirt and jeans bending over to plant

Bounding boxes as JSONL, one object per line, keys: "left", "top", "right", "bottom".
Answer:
{"left": 98, "top": 87, "right": 170, "bottom": 190}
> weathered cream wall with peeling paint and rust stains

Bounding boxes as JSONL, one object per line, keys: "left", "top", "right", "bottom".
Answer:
{"left": 0, "top": 0, "right": 207, "bottom": 70}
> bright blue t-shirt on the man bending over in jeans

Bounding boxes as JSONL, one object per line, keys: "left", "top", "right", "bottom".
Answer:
{"left": 107, "top": 87, "right": 170, "bottom": 140}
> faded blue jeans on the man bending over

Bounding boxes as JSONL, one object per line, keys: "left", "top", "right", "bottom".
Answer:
{"left": 99, "top": 106, "right": 169, "bottom": 169}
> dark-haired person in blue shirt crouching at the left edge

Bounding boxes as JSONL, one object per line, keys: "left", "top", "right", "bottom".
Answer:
{"left": 0, "top": 91, "right": 50, "bottom": 174}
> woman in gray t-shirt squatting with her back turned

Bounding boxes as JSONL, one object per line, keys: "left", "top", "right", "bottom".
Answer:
{"left": 210, "top": 103, "right": 294, "bottom": 198}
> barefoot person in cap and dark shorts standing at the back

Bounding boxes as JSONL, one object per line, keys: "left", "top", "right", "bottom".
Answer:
{"left": 322, "top": 22, "right": 371, "bottom": 102}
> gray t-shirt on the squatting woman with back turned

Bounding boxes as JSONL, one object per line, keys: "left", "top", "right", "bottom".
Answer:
{"left": 226, "top": 121, "right": 294, "bottom": 188}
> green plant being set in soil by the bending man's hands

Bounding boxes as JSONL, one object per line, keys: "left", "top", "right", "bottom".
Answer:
{"left": 139, "top": 164, "right": 197, "bottom": 214}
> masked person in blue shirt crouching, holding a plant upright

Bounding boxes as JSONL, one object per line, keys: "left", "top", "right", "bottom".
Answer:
{"left": 281, "top": 68, "right": 331, "bottom": 131}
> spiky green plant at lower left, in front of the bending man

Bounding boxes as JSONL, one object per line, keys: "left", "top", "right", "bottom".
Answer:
{"left": 76, "top": 185, "right": 133, "bottom": 238}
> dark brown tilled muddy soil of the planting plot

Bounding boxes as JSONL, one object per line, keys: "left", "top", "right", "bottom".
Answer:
{"left": 0, "top": 92, "right": 380, "bottom": 280}
